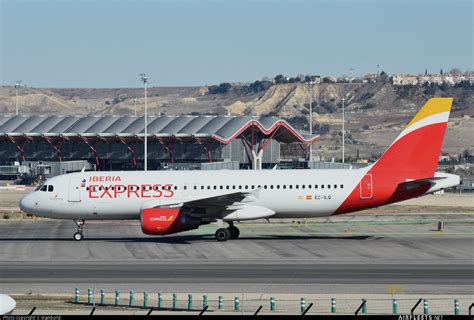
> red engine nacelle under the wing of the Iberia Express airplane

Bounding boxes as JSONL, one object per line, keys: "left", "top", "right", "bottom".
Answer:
{"left": 140, "top": 208, "right": 201, "bottom": 235}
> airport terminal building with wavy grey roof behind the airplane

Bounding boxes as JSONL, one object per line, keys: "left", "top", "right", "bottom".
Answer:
{"left": 0, "top": 115, "right": 318, "bottom": 179}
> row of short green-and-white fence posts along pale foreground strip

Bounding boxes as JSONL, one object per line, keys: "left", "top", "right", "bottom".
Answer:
{"left": 69, "top": 288, "right": 472, "bottom": 315}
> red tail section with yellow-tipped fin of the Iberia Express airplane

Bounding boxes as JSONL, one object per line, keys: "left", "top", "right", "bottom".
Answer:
{"left": 335, "top": 98, "right": 453, "bottom": 214}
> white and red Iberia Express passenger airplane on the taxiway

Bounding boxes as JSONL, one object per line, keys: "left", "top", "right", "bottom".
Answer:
{"left": 20, "top": 98, "right": 459, "bottom": 241}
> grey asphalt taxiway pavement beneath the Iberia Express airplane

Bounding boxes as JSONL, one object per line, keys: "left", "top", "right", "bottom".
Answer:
{"left": 0, "top": 215, "right": 474, "bottom": 294}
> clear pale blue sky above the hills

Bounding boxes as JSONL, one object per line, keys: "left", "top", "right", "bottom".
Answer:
{"left": 0, "top": 0, "right": 474, "bottom": 87}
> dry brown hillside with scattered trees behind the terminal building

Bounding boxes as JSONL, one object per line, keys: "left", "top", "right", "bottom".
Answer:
{"left": 0, "top": 83, "right": 474, "bottom": 159}
